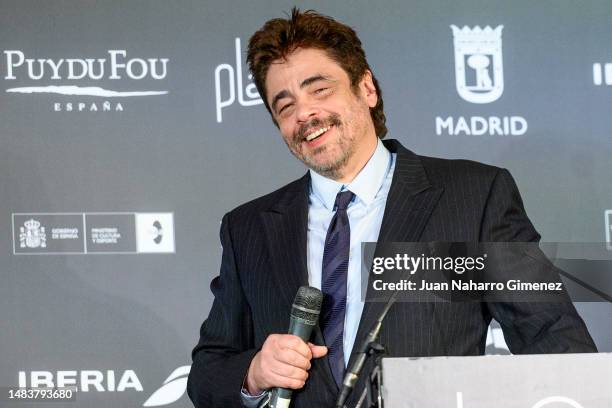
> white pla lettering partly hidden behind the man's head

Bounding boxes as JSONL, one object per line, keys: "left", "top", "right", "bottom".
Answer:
{"left": 215, "top": 38, "right": 263, "bottom": 123}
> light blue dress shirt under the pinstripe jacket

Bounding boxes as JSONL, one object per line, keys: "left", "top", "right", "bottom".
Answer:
{"left": 241, "top": 139, "right": 396, "bottom": 408}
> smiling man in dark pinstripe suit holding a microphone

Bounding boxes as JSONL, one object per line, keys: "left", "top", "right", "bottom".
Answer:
{"left": 188, "top": 9, "right": 595, "bottom": 407}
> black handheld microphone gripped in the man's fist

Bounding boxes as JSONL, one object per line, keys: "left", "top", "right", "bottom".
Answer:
{"left": 270, "top": 286, "right": 323, "bottom": 408}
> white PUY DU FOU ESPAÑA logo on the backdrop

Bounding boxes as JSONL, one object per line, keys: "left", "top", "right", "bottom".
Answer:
{"left": 3, "top": 50, "right": 169, "bottom": 112}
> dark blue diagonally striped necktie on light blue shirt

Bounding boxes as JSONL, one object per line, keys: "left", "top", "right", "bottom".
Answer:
{"left": 321, "top": 191, "right": 355, "bottom": 386}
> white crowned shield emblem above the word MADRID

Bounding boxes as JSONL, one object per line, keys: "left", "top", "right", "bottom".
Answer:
{"left": 451, "top": 25, "right": 504, "bottom": 103}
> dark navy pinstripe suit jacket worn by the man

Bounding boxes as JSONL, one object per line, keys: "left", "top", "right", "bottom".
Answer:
{"left": 188, "top": 140, "right": 596, "bottom": 408}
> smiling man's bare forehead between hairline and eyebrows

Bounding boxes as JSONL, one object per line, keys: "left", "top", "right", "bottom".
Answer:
{"left": 266, "top": 48, "right": 348, "bottom": 100}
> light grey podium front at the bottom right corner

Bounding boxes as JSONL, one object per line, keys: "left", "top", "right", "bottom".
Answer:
{"left": 382, "top": 353, "right": 612, "bottom": 408}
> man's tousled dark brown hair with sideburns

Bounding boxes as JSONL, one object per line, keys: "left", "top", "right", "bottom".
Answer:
{"left": 247, "top": 7, "right": 387, "bottom": 139}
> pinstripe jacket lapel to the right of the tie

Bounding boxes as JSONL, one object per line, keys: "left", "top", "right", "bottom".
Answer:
{"left": 349, "top": 140, "right": 443, "bottom": 366}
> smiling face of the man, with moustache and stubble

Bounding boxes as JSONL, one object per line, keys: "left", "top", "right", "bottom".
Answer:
{"left": 266, "top": 48, "right": 378, "bottom": 180}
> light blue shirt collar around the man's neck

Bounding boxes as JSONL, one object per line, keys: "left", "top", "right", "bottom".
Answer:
{"left": 310, "top": 139, "right": 391, "bottom": 211}
